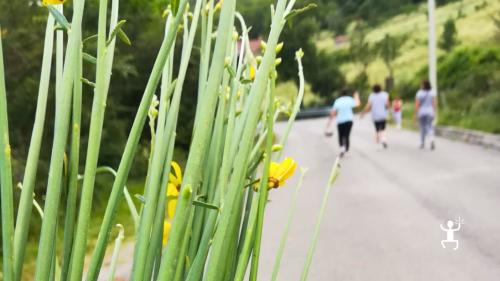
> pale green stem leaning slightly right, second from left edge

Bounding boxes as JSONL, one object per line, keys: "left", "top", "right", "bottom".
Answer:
{"left": 14, "top": 13, "right": 54, "bottom": 280}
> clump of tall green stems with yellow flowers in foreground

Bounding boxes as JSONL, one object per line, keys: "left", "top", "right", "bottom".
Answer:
{"left": 0, "top": 0, "right": 338, "bottom": 281}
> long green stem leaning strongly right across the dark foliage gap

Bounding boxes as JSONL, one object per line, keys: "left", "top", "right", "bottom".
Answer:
{"left": 87, "top": 1, "right": 186, "bottom": 276}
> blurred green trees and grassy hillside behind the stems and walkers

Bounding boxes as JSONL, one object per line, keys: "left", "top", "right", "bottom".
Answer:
{"left": 0, "top": 0, "right": 500, "bottom": 276}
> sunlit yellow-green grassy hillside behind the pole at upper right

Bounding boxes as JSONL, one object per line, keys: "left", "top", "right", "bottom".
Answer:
{"left": 317, "top": 0, "right": 500, "bottom": 83}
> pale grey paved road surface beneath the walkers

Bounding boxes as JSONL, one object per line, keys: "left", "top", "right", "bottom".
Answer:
{"left": 259, "top": 118, "right": 500, "bottom": 281}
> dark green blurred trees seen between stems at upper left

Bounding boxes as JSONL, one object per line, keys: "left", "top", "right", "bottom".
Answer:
{"left": 0, "top": 0, "right": 199, "bottom": 188}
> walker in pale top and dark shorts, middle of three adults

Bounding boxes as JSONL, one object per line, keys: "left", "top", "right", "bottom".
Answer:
{"left": 361, "top": 85, "right": 390, "bottom": 148}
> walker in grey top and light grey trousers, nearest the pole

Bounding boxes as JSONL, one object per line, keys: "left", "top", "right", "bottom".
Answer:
{"left": 413, "top": 80, "right": 437, "bottom": 150}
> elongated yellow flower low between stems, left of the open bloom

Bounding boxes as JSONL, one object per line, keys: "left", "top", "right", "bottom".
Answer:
{"left": 163, "top": 161, "right": 182, "bottom": 246}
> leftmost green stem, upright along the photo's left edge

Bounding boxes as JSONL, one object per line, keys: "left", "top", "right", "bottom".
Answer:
{"left": 0, "top": 24, "right": 14, "bottom": 280}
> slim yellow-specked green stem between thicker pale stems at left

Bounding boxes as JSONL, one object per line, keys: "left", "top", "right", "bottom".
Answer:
{"left": 61, "top": 39, "right": 83, "bottom": 280}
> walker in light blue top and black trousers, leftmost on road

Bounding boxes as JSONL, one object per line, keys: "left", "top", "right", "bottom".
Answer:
{"left": 325, "top": 90, "right": 361, "bottom": 157}
